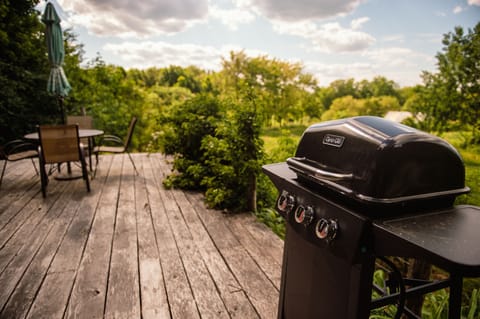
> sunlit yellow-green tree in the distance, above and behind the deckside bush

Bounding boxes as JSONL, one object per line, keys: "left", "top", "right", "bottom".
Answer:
{"left": 220, "top": 51, "right": 318, "bottom": 125}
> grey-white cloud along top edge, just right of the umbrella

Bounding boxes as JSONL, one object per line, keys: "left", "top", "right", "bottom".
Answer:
{"left": 58, "top": 0, "right": 208, "bottom": 37}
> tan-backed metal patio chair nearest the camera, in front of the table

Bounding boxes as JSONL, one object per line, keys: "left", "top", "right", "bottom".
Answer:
{"left": 38, "top": 124, "right": 90, "bottom": 197}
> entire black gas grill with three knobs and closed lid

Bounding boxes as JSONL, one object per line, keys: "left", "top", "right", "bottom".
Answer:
{"left": 264, "top": 116, "right": 480, "bottom": 319}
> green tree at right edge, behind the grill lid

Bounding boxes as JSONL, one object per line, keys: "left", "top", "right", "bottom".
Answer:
{"left": 413, "top": 23, "right": 480, "bottom": 143}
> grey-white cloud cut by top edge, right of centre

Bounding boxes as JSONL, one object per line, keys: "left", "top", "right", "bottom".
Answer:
{"left": 235, "top": 0, "right": 362, "bottom": 21}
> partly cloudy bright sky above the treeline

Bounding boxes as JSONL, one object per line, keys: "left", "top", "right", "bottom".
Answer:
{"left": 37, "top": 0, "right": 480, "bottom": 86}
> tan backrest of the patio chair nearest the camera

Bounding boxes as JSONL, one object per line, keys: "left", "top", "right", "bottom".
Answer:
{"left": 38, "top": 124, "right": 80, "bottom": 164}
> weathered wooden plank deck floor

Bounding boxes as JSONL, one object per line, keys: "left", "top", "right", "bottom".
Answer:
{"left": 0, "top": 154, "right": 283, "bottom": 319}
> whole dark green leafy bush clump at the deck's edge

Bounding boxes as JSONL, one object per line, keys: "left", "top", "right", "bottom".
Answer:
{"left": 161, "top": 95, "right": 266, "bottom": 211}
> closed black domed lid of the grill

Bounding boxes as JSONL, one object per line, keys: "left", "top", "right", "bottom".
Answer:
{"left": 287, "top": 116, "right": 470, "bottom": 204}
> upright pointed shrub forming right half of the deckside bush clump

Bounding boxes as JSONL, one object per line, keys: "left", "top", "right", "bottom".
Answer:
{"left": 202, "top": 102, "right": 263, "bottom": 211}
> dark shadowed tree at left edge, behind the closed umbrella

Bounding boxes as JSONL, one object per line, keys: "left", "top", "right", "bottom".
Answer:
{"left": 0, "top": 0, "right": 60, "bottom": 144}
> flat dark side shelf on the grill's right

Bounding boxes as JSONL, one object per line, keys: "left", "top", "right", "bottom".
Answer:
{"left": 373, "top": 205, "right": 480, "bottom": 277}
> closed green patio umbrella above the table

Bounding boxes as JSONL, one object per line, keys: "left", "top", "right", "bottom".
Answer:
{"left": 42, "top": 2, "right": 72, "bottom": 123}
